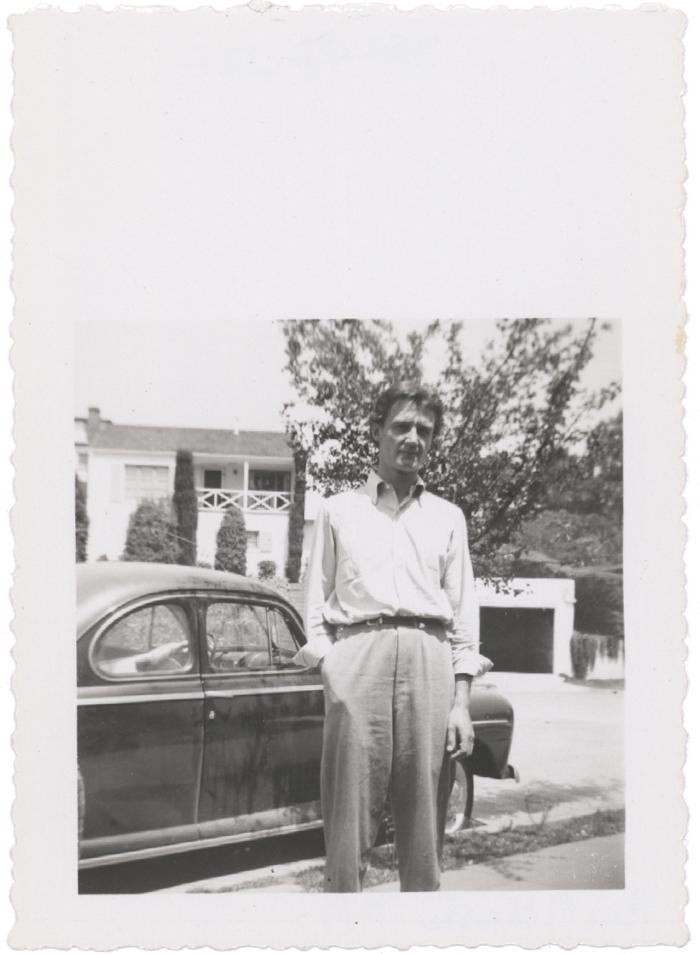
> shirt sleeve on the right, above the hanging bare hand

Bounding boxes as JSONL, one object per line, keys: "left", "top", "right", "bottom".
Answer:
{"left": 442, "top": 510, "right": 493, "bottom": 676}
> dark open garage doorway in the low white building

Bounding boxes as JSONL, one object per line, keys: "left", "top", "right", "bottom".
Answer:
{"left": 481, "top": 606, "right": 554, "bottom": 672}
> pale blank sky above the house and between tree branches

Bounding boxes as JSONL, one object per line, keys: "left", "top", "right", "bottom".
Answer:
{"left": 75, "top": 320, "right": 621, "bottom": 430}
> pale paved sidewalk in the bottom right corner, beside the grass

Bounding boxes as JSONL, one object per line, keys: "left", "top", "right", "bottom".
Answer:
{"left": 369, "top": 834, "right": 625, "bottom": 891}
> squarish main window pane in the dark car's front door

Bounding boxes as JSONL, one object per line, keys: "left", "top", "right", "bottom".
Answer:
{"left": 207, "top": 603, "right": 271, "bottom": 672}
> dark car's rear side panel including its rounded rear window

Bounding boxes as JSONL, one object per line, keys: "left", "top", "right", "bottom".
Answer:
{"left": 78, "top": 597, "right": 204, "bottom": 867}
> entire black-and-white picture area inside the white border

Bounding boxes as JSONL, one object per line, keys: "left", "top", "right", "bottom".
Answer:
{"left": 74, "top": 318, "right": 625, "bottom": 893}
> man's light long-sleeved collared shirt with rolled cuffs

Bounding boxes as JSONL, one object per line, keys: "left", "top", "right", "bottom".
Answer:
{"left": 296, "top": 473, "right": 493, "bottom": 676}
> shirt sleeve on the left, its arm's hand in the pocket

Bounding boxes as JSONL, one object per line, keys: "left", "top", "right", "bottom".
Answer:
{"left": 293, "top": 503, "right": 336, "bottom": 668}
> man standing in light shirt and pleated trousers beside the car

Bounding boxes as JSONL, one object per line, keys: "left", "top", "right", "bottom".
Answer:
{"left": 299, "top": 382, "right": 491, "bottom": 891}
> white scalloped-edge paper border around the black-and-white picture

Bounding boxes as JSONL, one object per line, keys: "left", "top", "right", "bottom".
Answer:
{"left": 11, "top": 7, "right": 686, "bottom": 950}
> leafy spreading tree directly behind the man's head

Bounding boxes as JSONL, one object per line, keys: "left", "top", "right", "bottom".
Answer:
{"left": 283, "top": 318, "right": 619, "bottom": 576}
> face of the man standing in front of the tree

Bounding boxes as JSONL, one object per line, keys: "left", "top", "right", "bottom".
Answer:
{"left": 372, "top": 401, "right": 435, "bottom": 474}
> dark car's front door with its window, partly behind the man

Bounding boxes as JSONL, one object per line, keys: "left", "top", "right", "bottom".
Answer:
{"left": 199, "top": 595, "right": 323, "bottom": 840}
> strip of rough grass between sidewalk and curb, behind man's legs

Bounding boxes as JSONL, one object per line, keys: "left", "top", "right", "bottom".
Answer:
{"left": 213, "top": 809, "right": 625, "bottom": 893}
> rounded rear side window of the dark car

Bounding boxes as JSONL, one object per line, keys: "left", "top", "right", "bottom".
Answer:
{"left": 92, "top": 603, "right": 194, "bottom": 678}
